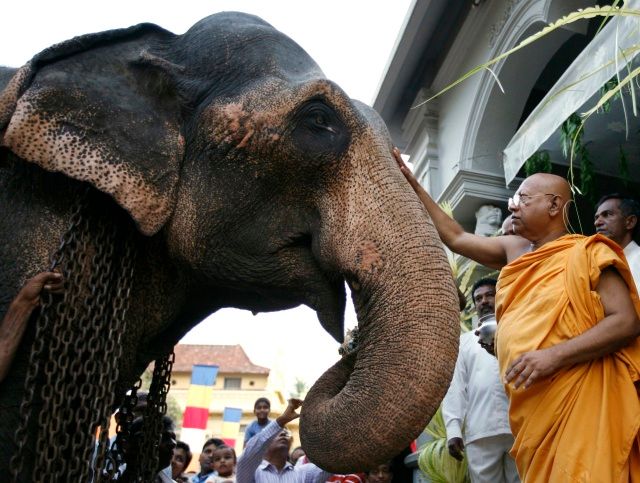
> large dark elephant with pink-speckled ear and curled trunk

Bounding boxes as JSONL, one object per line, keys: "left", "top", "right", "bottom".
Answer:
{"left": 0, "top": 12, "right": 459, "bottom": 474}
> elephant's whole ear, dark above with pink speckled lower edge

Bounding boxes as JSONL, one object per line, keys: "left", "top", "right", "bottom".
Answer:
{"left": 0, "top": 24, "right": 184, "bottom": 235}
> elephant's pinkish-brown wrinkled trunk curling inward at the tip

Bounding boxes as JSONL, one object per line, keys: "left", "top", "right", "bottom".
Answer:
{"left": 300, "top": 151, "right": 460, "bottom": 473}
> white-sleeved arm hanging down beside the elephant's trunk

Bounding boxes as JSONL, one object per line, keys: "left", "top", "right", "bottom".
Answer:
{"left": 442, "top": 340, "right": 467, "bottom": 461}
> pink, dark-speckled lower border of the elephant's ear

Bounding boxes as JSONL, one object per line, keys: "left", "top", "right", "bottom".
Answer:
{"left": 2, "top": 96, "right": 175, "bottom": 235}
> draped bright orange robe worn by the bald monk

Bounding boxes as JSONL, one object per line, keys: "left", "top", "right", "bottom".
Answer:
{"left": 496, "top": 235, "right": 640, "bottom": 483}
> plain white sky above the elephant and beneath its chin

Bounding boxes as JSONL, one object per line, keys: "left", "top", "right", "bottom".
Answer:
{"left": 0, "top": 0, "right": 414, "bottom": 390}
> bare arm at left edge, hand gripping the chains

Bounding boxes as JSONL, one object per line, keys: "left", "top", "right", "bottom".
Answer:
{"left": 0, "top": 272, "right": 63, "bottom": 382}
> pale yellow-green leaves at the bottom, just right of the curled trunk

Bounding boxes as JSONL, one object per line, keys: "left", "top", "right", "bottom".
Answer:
{"left": 418, "top": 407, "right": 470, "bottom": 483}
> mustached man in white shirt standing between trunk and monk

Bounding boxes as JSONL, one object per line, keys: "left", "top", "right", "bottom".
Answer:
{"left": 442, "top": 278, "right": 520, "bottom": 483}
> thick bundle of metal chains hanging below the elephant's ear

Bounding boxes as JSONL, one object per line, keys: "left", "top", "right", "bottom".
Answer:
{"left": 11, "top": 189, "right": 140, "bottom": 482}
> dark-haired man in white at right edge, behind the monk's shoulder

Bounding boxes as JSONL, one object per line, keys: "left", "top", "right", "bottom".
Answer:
{"left": 594, "top": 193, "right": 640, "bottom": 290}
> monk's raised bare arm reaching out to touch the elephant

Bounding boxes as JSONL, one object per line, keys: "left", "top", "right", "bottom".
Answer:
{"left": 393, "top": 148, "right": 516, "bottom": 269}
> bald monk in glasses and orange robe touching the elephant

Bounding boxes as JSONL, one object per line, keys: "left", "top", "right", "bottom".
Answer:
{"left": 396, "top": 149, "right": 640, "bottom": 483}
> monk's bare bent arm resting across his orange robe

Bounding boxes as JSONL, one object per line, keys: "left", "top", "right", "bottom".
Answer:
{"left": 505, "top": 268, "right": 640, "bottom": 388}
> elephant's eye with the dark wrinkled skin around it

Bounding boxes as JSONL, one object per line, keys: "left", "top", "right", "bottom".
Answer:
{"left": 292, "top": 99, "right": 350, "bottom": 157}
